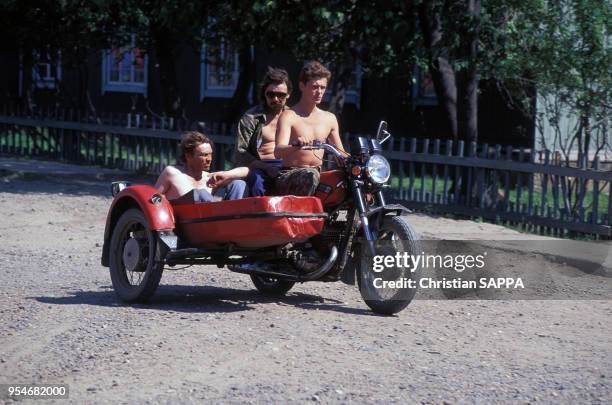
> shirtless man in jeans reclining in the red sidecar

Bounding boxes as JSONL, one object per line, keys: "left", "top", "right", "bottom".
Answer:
{"left": 155, "top": 131, "right": 248, "bottom": 203}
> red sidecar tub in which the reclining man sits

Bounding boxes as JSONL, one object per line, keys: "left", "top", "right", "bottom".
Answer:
{"left": 173, "top": 196, "right": 326, "bottom": 248}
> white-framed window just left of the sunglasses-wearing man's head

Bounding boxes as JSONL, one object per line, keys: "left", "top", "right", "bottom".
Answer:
{"left": 200, "top": 42, "right": 239, "bottom": 99}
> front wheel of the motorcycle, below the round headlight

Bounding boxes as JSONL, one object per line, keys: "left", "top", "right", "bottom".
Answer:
{"left": 355, "top": 216, "right": 421, "bottom": 315}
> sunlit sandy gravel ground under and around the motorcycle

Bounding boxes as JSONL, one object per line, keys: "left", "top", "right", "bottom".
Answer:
{"left": 0, "top": 158, "right": 612, "bottom": 404}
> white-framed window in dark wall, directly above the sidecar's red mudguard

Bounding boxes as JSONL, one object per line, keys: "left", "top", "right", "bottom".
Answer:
{"left": 102, "top": 35, "right": 149, "bottom": 95}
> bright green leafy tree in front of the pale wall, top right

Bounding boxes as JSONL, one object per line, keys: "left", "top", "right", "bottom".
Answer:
{"left": 501, "top": 0, "right": 612, "bottom": 165}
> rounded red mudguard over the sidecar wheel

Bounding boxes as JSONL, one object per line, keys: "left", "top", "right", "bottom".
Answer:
{"left": 101, "top": 184, "right": 175, "bottom": 267}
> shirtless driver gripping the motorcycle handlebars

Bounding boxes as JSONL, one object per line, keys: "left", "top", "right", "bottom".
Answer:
{"left": 274, "top": 61, "right": 344, "bottom": 196}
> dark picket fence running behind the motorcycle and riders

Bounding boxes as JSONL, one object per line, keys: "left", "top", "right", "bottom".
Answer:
{"left": 0, "top": 105, "right": 612, "bottom": 238}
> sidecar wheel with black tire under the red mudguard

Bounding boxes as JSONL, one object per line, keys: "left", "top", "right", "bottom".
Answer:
{"left": 110, "top": 208, "right": 165, "bottom": 302}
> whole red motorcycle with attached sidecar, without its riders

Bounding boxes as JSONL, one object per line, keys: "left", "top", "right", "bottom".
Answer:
{"left": 101, "top": 121, "right": 421, "bottom": 314}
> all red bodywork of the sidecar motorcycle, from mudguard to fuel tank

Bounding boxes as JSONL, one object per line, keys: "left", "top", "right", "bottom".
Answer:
{"left": 102, "top": 181, "right": 334, "bottom": 266}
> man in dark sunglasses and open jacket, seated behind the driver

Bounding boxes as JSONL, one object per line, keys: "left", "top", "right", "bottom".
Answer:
{"left": 234, "top": 67, "right": 291, "bottom": 197}
